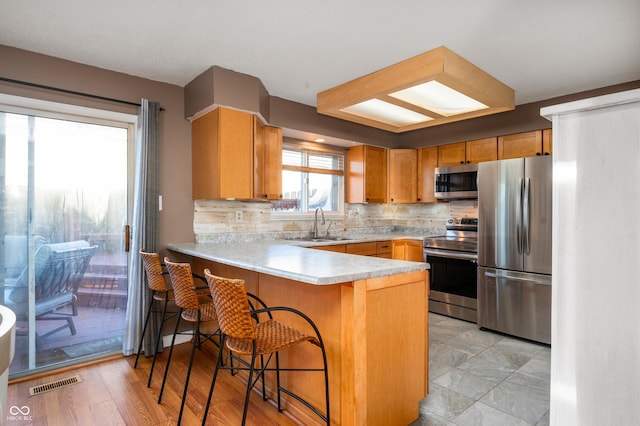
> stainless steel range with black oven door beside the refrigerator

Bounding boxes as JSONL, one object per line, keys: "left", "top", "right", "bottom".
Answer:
{"left": 424, "top": 218, "right": 478, "bottom": 323}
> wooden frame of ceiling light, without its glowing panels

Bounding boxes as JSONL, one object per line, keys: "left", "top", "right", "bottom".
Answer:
{"left": 317, "top": 46, "right": 515, "bottom": 133}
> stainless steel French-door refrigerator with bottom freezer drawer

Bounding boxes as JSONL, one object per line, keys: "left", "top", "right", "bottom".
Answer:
{"left": 478, "top": 157, "right": 552, "bottom": 344}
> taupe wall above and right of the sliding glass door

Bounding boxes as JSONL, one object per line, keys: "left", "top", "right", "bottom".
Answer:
{"left": 0, "top": 45, "right": 194, "bottom": 260}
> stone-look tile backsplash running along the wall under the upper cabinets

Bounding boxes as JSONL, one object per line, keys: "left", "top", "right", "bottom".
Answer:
{"left": 193, "top": 200, "right": 478, "bottom": 242}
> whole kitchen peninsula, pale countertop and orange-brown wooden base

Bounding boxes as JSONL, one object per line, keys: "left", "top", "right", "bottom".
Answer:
{"left": 167, "top": 241, "right": 428, "bottom": 425}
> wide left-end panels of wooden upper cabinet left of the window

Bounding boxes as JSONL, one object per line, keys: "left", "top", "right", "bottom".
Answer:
{"left": 191, "top": 108, "right": 254, "bottom": 200}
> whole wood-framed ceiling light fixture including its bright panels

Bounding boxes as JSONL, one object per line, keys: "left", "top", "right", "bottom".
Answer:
{"left": 318, "top": 46, "right": 515, "bottom": 133}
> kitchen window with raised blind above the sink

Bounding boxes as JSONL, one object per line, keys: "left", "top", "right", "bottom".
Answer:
{"left": 271, "top": 142, "right": 344, "bottom": 215}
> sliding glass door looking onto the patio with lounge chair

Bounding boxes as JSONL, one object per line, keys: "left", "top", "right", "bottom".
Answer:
{"left": 0, "top": 105, "right": 133, "bottom": 377}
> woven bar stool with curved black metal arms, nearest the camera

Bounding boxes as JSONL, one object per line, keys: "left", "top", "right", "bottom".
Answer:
{"left": 202, "top": 269, "right": 330, "bottom": 425}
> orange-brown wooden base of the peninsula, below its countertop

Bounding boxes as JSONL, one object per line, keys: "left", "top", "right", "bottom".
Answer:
{"left": 184, "top": 252, "right": 429, "bottom": 426}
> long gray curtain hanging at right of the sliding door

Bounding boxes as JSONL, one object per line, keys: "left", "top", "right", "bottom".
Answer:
{"left": 122, "top": 99, "right": 160, "bottom": 356}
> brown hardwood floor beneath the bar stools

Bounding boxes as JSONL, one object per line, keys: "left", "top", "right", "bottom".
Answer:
{"left": 5, "top": 343, "right": 298, "bottom": 426}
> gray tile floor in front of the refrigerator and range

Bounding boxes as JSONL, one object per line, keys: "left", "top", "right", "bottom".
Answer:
{"left": 412, "top": 313, "right": 551, "bottom": 426}
